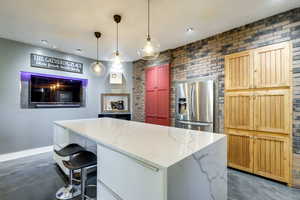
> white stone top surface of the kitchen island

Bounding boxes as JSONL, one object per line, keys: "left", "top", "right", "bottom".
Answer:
{"left": 54, "top": 118, "right": 226, "bottom": 168}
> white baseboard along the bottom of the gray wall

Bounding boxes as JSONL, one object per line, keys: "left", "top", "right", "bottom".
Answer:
{"left": 0, "top": 145, "right": 53, "bottom": 162}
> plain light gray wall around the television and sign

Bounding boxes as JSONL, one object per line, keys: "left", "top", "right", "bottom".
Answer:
{"left": 0, "top": 38, "right": 132, "bottom": 154}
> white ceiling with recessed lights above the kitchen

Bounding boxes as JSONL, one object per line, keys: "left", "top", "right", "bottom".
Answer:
{"left": 0, "top": 0, "right": 300, "bottom": 61}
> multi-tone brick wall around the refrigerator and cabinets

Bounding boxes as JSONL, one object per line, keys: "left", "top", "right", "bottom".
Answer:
{"left": 133, "top": 8, "right": 300, "bottom": 187}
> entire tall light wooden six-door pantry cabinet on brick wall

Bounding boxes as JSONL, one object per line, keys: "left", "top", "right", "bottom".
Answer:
{"left": 224, "top": 42, "right": 292, "bottom": 184}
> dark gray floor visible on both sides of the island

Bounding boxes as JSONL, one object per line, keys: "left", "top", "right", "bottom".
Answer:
{"left": 0, "top": 153, "right": 300, "bottom": 200}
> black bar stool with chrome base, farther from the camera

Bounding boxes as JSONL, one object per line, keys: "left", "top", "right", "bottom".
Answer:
{"left": 54, "top": 144, "right": 85, "bottom": 200}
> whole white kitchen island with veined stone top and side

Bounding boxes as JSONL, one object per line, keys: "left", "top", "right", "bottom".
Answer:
{"left": 54, "top": 118, "right": 227, "bottom": 200}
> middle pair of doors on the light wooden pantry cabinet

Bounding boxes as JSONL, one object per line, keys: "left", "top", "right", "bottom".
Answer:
{"left": 225, "top": 89, "right": 291, "bottom": 134}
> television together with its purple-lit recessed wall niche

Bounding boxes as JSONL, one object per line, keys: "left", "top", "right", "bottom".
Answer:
{"left": 21, "top": 72, "right": 87, "bottom": 108}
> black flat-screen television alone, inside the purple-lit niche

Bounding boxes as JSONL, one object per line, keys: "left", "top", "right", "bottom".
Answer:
{"left": 29, "top": 75, "right": 83, "bottom": 107}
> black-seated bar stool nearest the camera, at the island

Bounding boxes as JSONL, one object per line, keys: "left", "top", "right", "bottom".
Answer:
{"left": 63, "top": 151, "right": 97, "bottom": 200}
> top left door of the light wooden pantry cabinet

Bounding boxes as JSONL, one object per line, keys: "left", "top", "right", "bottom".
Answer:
{"left": 225, "top": 51, "right": 253, "bottom": 90}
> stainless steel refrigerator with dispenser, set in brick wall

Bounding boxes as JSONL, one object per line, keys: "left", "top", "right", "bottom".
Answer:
{"left": 175, "top": 80, "right": 214, "bottom": 132}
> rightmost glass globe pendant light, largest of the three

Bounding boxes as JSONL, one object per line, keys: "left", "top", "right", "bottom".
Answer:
{"left": 138, "top": 0, "right": 160, "bottom": 60}
